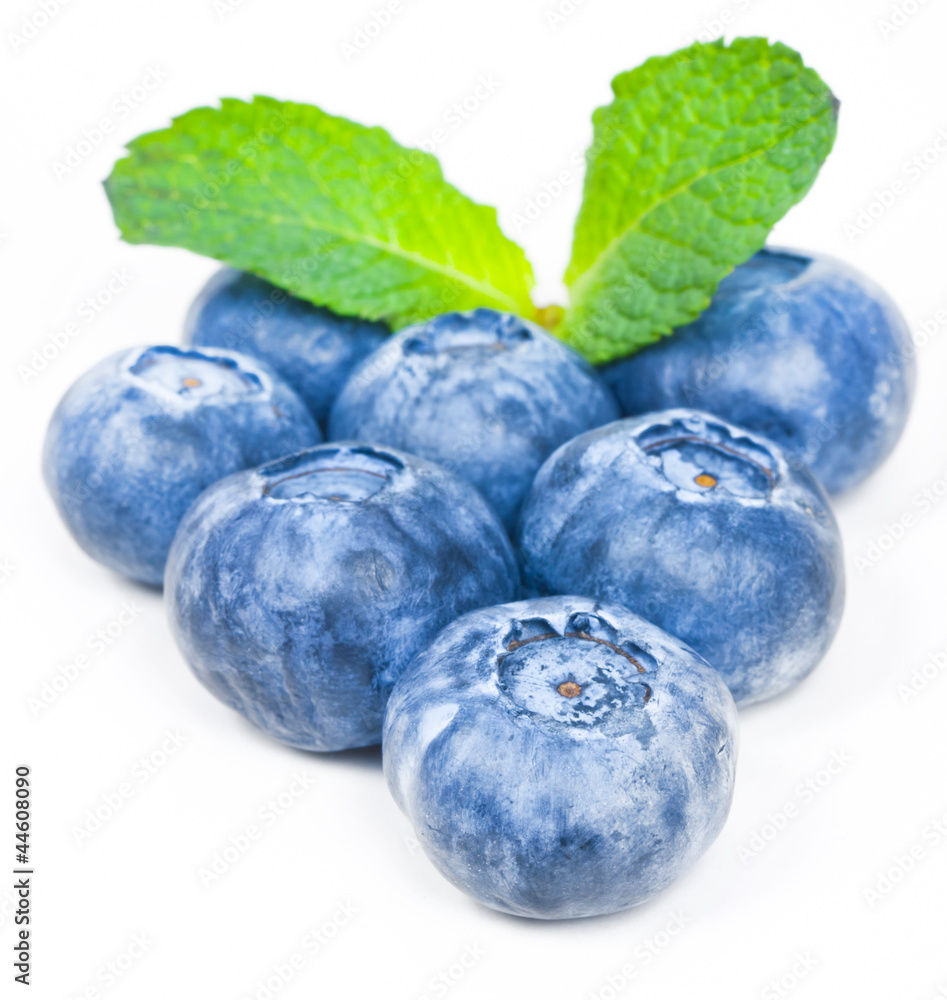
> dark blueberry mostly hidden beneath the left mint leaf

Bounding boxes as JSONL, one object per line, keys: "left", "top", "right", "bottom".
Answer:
{"left": 184, "top": 268, "right": 389, "bottom": 422}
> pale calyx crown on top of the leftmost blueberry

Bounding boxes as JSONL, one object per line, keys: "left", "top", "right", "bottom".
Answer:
{"left": 128, "top": 346, "right": 264, "bottom": 402}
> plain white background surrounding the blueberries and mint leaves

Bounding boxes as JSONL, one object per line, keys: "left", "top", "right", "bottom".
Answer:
{"left": 0, "top": 0, "right": 947, "bottom": 1000}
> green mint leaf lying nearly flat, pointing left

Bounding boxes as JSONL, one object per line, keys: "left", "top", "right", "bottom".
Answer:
{"left": 105, "top": 97, "right": 535, "bottom": 328}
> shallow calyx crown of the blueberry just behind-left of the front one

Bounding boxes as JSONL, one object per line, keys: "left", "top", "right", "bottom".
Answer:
{"left": 259, "top": 445, "right": 404, "bottom": 503}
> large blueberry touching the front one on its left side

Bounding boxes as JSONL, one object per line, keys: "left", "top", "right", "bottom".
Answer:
{"left": 165, "top": 443, "right": 519, "bottom": 750}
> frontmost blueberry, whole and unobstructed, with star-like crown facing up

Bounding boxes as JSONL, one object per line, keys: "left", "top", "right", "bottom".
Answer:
{"left": 383, "top": 597, "right": 737, "bottom": 918}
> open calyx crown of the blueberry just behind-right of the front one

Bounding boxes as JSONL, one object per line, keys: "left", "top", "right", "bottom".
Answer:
{"left": 635, "top": 416, "right": 778, "bottom": 500}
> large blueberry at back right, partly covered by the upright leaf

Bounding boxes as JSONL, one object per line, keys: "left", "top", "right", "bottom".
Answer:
{"left": 603, "top": 249, "right": 915, "bottom": 493}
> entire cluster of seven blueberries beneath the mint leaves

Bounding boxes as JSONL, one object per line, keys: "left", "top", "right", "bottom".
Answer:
{"left": 43, "top": 250, "right": 914, "bottom": 918}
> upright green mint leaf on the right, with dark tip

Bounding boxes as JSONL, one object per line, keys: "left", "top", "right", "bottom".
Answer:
{"left": 558, "top": 38, "right": 838, "bottom": 362}
